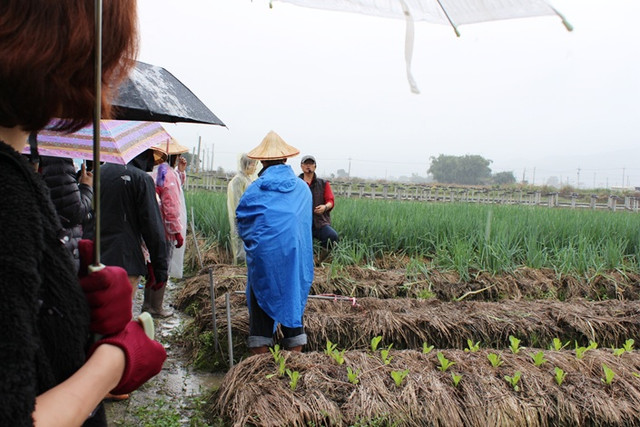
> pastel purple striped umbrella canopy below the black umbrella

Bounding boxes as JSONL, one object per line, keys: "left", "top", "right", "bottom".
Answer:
{"left": 23, "top": 120, "right": 171, "bottom": 165}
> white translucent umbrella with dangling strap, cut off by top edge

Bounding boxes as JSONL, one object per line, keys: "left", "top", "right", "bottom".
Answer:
{"left": 271, "top": 0, "right": 573, "bottom": 93}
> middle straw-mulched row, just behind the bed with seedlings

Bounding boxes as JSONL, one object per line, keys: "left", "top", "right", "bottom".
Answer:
{"left": 175, "top": 280, "right": 640, "bottom": 362}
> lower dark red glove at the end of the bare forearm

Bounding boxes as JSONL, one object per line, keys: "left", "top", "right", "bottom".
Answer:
{"left": 89, "top": 321, "right": 167, "bottom": 394}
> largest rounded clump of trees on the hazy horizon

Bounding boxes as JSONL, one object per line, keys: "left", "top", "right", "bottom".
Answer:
{"left": 427, "top": 154, "right": 491, "bottom": 185}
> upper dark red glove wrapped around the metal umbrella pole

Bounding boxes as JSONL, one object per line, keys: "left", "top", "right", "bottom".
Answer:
{"left": 78, "top": 240, "right": 133, "bottom": 335}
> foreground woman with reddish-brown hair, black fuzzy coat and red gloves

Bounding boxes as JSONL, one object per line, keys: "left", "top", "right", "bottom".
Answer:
{"left": 0, "top": 0, "right": 166, "bottom": 427}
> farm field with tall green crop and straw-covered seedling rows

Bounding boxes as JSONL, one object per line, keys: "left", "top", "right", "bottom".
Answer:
{"left": 176, "top": 192, "right": 640, "bottom": 426}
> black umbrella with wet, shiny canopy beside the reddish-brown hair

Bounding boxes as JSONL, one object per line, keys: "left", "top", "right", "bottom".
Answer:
{"left": 112, "top": 61, "right": 225, "bottom": 126}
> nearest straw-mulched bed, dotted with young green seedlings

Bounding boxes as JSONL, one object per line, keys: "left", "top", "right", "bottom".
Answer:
{"left": 208, "top": 348, "right": 640, "bottom": 427}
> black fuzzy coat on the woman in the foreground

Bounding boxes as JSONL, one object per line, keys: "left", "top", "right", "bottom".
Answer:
{"left": 0, "top": 142, "right": 106, "bottom": 426}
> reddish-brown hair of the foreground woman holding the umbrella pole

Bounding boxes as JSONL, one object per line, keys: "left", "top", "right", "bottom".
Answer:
{"left": 0, "top": 0, "right": 138, "bottom": 131}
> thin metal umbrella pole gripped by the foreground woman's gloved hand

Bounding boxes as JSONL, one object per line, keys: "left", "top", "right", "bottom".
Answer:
{"left": 93, "top": 0, "right": 102, "bottom": 268}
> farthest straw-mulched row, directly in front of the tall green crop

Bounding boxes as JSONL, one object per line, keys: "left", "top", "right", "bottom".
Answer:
{"left": 175, "top": 264, "right": 640, "bottom": 304}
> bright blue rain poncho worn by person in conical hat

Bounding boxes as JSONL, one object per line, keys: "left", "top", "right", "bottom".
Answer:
{"left": 236, "top": 165, "right": 313, "bottom": 328}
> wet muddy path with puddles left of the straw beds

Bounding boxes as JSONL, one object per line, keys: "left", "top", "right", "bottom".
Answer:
{"left": 105, "top": 282, "right": 224, "bottom": 427}
